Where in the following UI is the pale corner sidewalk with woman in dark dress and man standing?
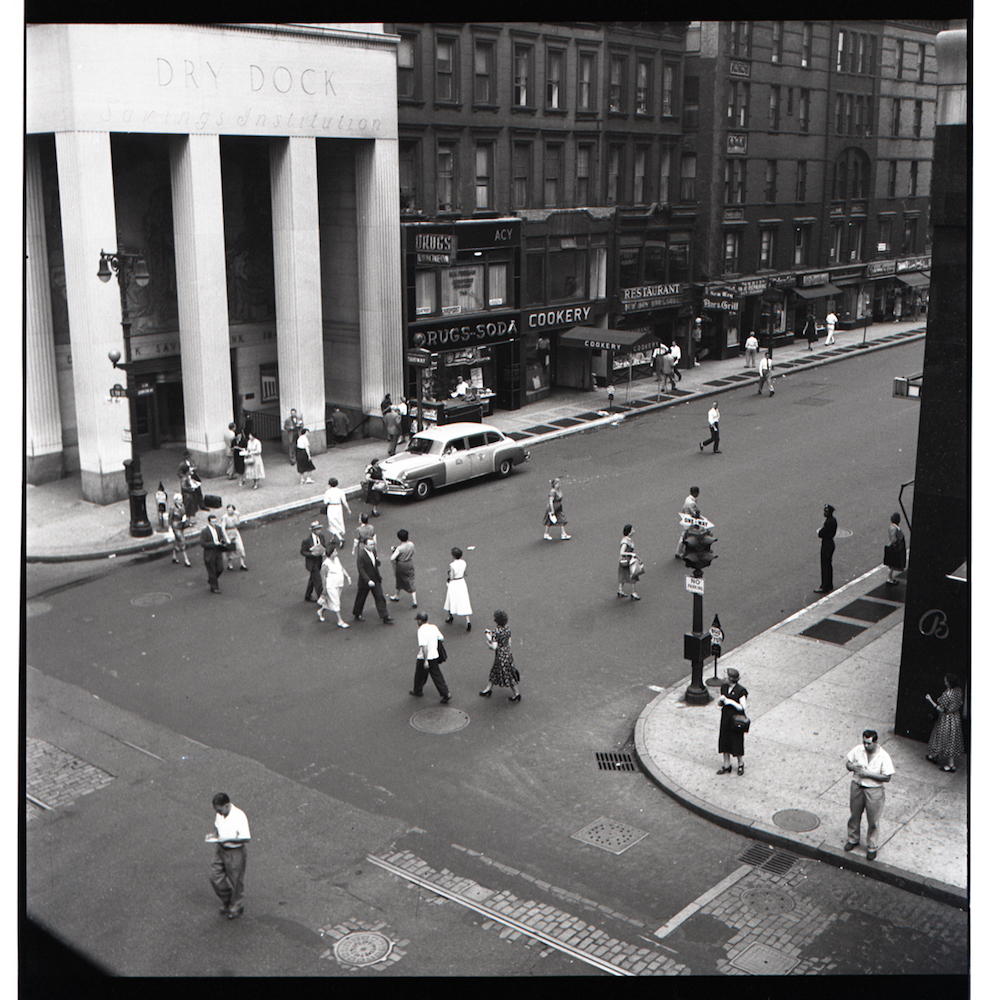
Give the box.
[635,567,969,909]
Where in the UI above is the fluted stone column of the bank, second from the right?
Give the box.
[271,136,326,454]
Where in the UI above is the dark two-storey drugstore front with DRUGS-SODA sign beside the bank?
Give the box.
[403,218,524,422]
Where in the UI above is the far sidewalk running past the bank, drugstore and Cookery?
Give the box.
[24,320,926,562]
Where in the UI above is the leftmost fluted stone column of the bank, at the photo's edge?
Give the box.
[24,136,64,485]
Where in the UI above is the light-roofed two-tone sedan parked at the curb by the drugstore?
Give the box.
[379,423,529,500]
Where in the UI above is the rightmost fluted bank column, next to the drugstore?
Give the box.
[355,139,405,415]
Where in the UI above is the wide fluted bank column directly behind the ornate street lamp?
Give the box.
[56,132,132,504]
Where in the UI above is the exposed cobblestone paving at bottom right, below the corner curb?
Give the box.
[369,842,968,976]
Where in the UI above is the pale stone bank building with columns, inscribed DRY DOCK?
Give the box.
[25,22,404,503]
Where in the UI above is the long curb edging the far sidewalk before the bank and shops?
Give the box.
[24,328,927,564]
